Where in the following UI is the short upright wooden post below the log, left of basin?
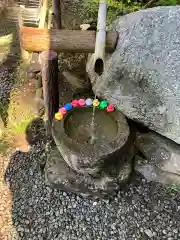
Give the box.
[39,51,59,135]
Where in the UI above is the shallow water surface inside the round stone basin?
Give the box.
[64,108,117,144]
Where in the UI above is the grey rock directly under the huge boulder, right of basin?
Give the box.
[136,132,180,175]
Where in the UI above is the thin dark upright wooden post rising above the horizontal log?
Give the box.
[53,0,62,29]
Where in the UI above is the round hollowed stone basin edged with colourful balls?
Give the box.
[52,107,130,175]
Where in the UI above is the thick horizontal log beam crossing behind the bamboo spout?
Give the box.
[20,27,117,53]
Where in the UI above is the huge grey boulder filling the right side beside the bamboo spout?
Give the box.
[87,6,180,143]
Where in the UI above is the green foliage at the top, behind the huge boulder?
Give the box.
[83,0,180,24]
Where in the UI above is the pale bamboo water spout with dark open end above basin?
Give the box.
[94,0,107,75]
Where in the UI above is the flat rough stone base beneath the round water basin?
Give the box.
[45,149,131,197]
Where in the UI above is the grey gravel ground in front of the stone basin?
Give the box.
[0,143,180,240]
